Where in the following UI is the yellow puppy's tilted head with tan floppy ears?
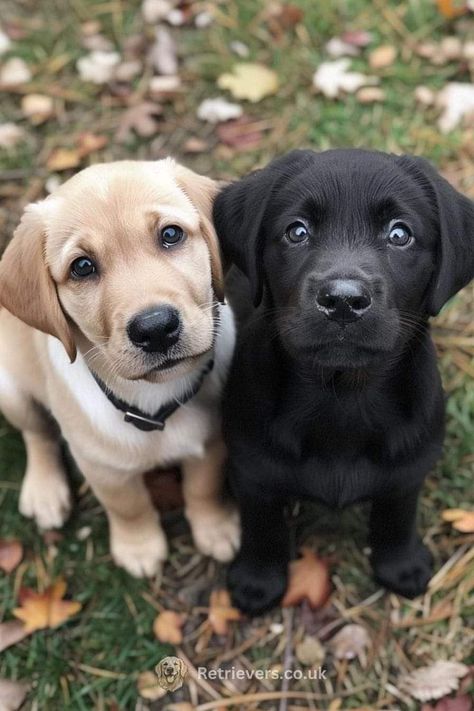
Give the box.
[0,159,222,382]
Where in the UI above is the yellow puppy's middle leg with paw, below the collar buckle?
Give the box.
[73,452,168,578]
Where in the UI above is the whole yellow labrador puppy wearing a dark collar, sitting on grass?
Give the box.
[0,159,239,576]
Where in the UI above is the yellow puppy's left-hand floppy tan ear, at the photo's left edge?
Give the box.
[0,205,76,362]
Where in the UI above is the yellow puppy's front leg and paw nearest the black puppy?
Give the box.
[182,440,240,562]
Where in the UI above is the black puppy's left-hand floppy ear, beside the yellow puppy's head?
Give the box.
[213,151,313,306]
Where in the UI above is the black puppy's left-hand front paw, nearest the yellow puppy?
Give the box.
[227,555,288,617]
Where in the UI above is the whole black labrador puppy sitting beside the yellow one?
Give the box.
[214,150,474,614]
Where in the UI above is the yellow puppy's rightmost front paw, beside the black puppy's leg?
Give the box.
[186,507,240,563]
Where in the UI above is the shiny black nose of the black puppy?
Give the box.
[316,279,372,323]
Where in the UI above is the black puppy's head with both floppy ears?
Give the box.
[214,145,474,368]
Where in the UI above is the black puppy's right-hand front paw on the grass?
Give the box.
[372,541,433,598]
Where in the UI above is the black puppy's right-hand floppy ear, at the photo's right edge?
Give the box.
[398,156,474,316]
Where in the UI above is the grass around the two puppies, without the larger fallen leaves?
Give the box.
[0,0,474,711]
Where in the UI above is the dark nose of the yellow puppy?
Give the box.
[127,305,181,353]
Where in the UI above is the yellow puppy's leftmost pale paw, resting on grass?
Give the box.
[19,471,71,530]
